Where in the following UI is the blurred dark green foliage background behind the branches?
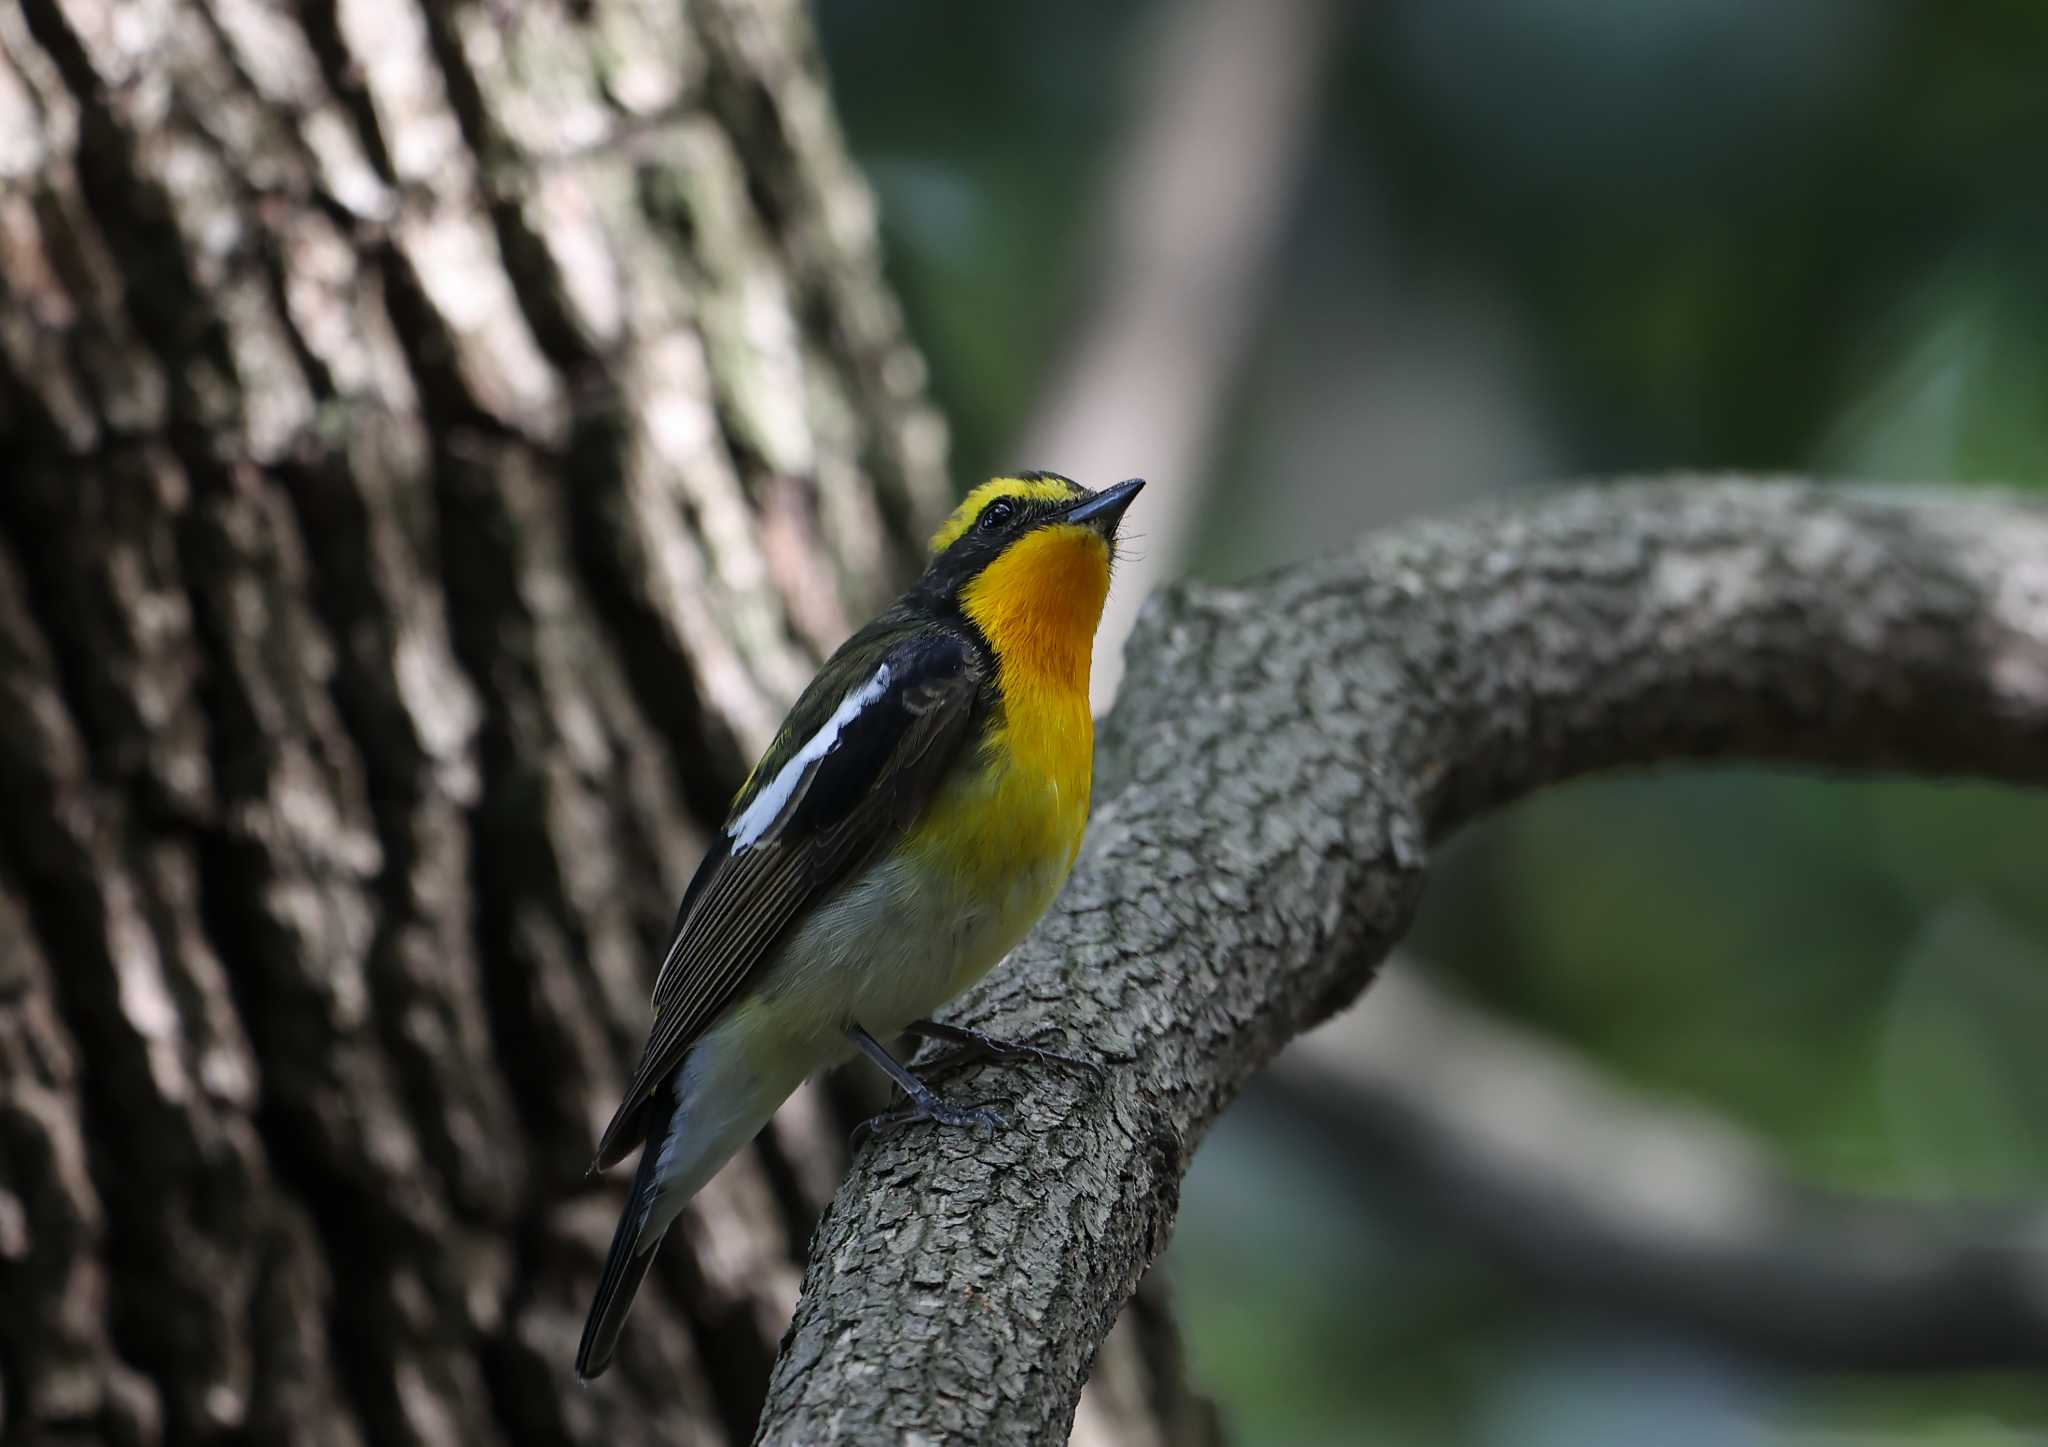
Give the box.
[815,0,2048,1447]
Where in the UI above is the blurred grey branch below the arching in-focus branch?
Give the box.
[1270,962,2048,1369]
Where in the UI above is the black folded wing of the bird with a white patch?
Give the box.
[598,630,985,1171]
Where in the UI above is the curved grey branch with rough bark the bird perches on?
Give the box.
[758,483,2048,1443]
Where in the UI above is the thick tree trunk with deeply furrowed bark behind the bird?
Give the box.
[0,0,1182,1447]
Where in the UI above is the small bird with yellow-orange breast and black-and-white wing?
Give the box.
[575,473,1145,1382]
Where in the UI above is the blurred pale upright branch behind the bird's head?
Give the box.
[1016,0,1337,712]
